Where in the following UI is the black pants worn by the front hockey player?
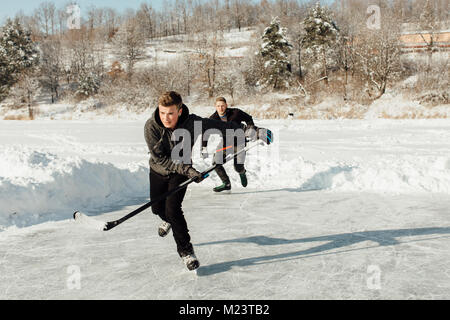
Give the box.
[150,169,193,256]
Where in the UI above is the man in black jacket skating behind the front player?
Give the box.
[201,97,255,192]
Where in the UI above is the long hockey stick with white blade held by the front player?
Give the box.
[73,141,263,231]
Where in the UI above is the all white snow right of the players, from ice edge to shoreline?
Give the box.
[194,120,450,194]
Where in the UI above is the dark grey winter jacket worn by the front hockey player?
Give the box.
[144,104,245,176]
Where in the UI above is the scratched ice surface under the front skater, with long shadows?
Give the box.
[0,188,450,299]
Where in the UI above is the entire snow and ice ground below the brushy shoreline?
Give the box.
[0,118,450,299]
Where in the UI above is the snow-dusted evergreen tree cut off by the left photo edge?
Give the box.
[0,19,39,100]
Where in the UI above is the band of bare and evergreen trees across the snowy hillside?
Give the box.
[0,0,449,117]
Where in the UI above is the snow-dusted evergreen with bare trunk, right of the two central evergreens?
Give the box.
[302,2,339,83]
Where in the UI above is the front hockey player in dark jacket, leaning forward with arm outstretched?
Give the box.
[144,91,270,270]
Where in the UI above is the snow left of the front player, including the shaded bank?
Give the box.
[0,121,148,227]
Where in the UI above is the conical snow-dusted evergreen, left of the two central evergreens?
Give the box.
[258,17,292,89]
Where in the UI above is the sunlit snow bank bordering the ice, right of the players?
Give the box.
[197,147,450,194]
